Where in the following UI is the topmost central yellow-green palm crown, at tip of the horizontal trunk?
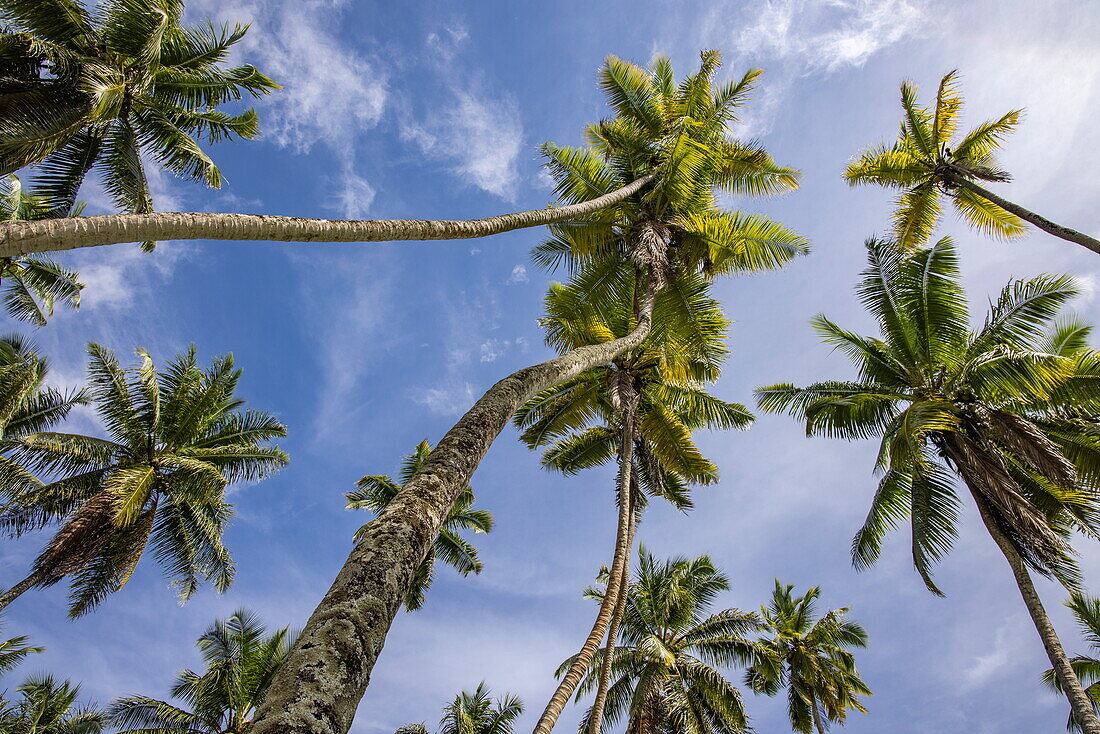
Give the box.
[534,51,809,290]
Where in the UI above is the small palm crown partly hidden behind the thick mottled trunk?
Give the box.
[344,441,493,612]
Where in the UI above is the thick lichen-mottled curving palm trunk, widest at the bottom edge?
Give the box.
[250,272,658,734]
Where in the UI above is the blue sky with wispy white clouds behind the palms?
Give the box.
[0,0,1100,734]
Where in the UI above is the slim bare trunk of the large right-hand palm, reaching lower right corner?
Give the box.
[970,489,1100,734]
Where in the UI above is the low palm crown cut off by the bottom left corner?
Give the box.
[0,676,107,734]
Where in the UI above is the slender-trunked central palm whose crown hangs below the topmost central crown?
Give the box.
[514,270,752,734]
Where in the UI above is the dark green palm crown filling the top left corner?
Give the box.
[0,0,277,232]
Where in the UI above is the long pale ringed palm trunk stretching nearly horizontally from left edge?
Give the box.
[0,174,653,258]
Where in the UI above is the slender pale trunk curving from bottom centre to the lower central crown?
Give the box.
[535,407,636,734]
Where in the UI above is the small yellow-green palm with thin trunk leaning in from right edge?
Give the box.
[845,72,1100,253]
